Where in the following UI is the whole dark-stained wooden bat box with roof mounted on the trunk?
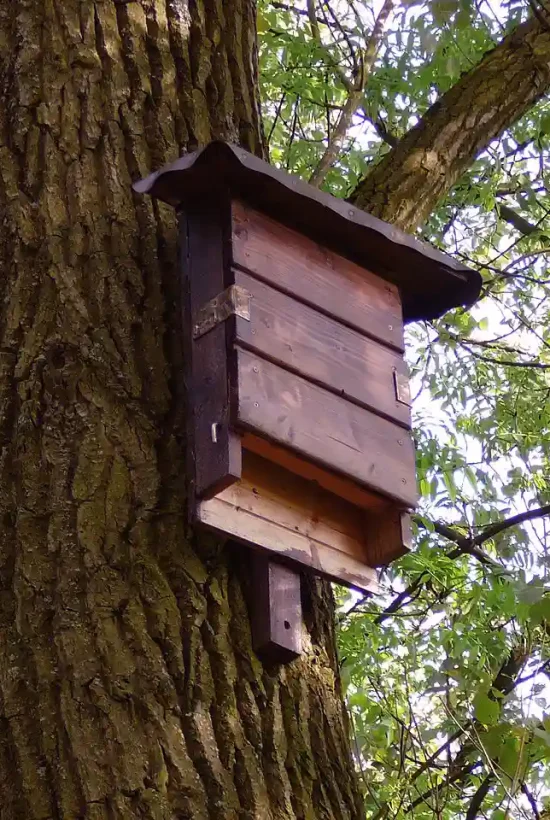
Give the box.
[134,143,481,660]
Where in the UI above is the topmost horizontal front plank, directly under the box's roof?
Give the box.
[232,201,403,350]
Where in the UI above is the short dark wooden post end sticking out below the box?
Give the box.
[250,552,302,663]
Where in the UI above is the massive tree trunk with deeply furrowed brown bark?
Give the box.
[0,0,361,820]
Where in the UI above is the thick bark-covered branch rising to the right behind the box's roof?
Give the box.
[351,18,550,232]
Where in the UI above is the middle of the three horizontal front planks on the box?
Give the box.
[234,270,410,428]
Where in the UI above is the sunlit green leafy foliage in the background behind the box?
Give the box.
[259,0,550,820]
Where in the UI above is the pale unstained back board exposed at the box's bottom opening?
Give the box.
[196,453,377,592]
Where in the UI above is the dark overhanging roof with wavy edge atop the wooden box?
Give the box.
[134,142,481,321]
